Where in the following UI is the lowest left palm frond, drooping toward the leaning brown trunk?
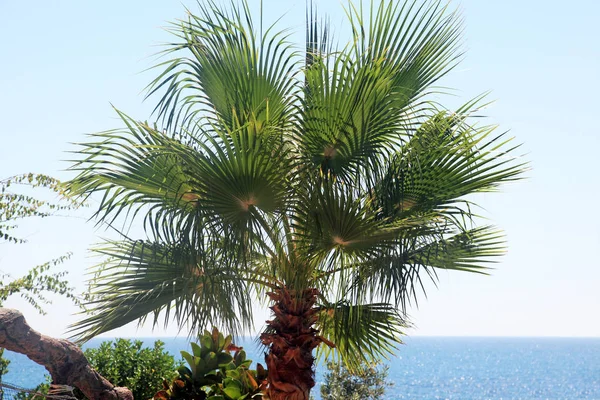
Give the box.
[72,236,258,341]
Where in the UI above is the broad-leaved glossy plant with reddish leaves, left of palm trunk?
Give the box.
[154,328,267,400]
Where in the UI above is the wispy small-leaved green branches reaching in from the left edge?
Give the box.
[0,173,79,380]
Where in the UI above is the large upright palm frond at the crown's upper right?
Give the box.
[297,1,461,179]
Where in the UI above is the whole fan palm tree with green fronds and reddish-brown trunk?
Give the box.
[69,1,524,400]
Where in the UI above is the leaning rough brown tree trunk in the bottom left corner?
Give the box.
[0,308,133,400]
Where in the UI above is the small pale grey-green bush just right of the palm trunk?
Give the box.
[321,362,393,400]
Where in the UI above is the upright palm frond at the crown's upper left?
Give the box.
[148,0,299,134]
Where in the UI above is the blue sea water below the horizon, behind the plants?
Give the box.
[4,337,600,400]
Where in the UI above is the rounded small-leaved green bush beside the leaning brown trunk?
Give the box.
[76,339,180,399]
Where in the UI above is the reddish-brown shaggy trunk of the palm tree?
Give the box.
[260,288,332,400]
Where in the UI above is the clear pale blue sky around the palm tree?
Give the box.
[0,0,600,336]
